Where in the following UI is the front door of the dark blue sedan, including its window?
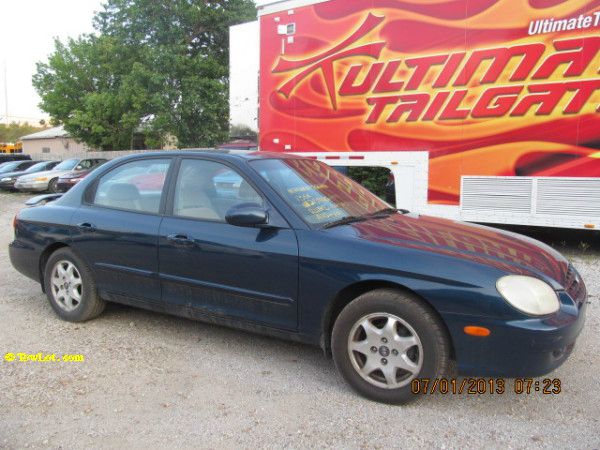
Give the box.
[159,158,298,330]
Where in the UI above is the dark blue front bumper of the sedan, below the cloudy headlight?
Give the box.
[445,292,587,378]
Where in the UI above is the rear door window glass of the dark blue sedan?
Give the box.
[93,159,171,214]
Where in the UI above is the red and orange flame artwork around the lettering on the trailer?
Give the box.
[260,0,600,205]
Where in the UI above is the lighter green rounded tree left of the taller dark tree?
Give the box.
[33,35,151,150]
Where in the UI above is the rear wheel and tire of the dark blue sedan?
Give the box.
[44,247,105,322]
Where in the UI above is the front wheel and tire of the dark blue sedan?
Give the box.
[331,289,451,404]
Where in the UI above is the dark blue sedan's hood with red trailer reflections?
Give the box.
[327,214,569,285]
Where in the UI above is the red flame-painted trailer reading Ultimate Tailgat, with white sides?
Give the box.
[230,0,600,229]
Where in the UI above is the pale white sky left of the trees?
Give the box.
[0,0,103,123]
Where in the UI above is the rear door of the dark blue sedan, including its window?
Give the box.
[71,157,172,303]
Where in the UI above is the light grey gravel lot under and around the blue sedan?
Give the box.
[0,194,600,449]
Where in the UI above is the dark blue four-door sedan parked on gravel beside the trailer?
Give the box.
[10,152,587,403]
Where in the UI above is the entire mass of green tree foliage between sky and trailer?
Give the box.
[33,0,256,150]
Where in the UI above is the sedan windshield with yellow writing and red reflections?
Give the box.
[250,159,390,225]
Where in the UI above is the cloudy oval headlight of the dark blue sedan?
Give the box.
[496,275,560,316]
